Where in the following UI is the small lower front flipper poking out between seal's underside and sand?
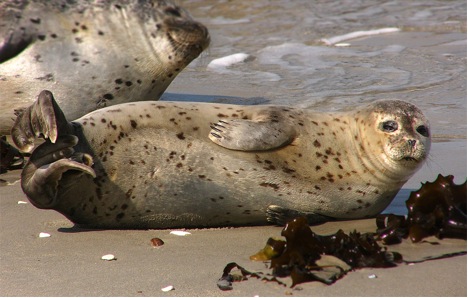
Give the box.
[266,205,334,226]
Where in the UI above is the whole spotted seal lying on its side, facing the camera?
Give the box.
[12,91,431,228]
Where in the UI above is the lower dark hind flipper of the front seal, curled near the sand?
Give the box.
[21,135,96,209]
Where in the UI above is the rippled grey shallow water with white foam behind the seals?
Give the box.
[164,0,467,138]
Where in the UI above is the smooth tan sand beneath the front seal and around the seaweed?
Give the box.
[0,140,467,296]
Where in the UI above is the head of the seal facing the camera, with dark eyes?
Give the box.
[356,100,431,179]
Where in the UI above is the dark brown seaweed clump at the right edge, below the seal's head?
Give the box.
[377,174,467,244]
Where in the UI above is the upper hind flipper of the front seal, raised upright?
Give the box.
[11,90,71,152]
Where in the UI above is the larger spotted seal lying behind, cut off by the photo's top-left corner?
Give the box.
[0,0,210,134]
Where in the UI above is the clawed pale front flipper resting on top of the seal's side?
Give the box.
[209,119,294,151]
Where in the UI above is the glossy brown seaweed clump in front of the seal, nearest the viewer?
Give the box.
[218,217,402,290]
